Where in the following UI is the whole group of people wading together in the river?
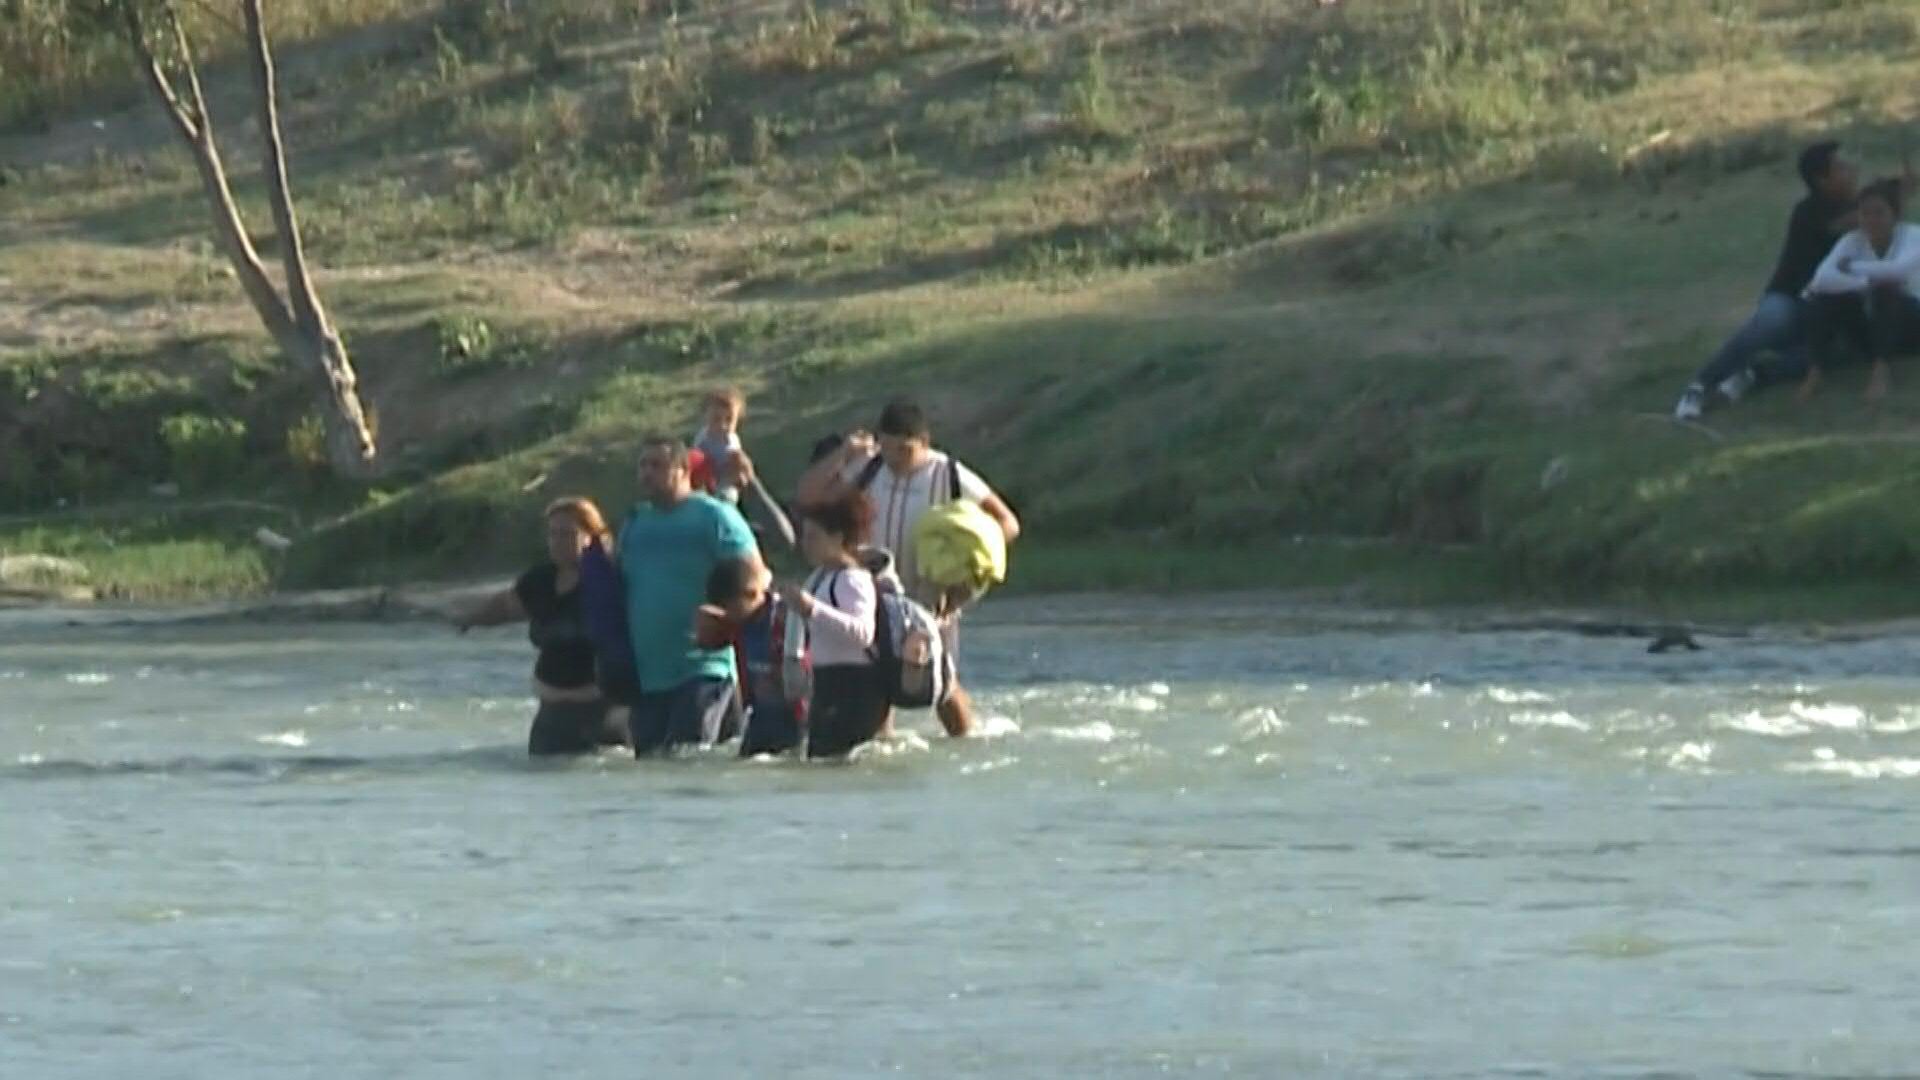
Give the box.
[455,390,1020,757]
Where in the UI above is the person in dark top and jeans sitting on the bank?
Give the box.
[1674,142,1859,421]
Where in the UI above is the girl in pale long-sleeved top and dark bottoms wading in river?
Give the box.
[785,492,889,757]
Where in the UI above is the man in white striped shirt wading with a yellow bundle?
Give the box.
[799,402,1020,736]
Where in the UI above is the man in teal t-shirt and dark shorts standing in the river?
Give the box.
[620,436,760,755]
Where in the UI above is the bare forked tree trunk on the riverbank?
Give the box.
[123,0,376,477]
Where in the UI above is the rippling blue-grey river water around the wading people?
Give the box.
[0,601,1920,1080]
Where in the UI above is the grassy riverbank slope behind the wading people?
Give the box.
[0,0,1920,617]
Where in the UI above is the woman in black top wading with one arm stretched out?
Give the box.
[453,500,626,755]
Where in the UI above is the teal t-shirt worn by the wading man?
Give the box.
[620,494,756,694]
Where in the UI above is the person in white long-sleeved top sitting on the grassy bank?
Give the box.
[1801,181,1920,402]
